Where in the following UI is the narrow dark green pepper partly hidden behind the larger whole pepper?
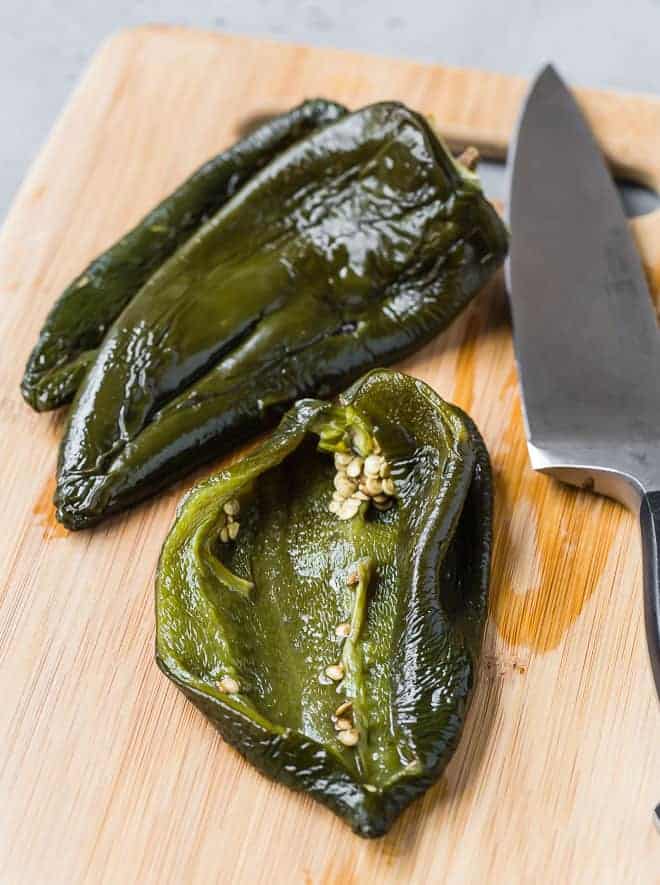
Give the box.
[21,99,346,412]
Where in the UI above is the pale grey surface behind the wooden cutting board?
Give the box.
[0,0,660,219]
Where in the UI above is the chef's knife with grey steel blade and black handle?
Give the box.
[507,66,660,696]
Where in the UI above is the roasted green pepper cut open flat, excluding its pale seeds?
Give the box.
[156,370,492,837]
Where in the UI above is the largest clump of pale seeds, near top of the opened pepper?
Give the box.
[328,443,396,519]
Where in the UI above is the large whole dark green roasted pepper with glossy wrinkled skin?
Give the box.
[55,102,507,529]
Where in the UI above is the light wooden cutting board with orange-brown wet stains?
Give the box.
[0,27,660,885]
